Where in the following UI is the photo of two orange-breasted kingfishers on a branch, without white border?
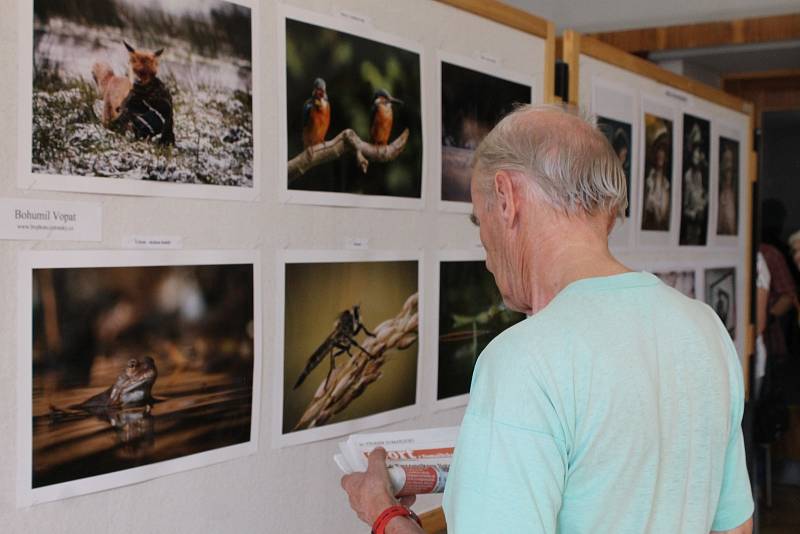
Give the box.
[286,18,423,198]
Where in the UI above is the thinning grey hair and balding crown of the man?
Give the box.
[472,105,630,217]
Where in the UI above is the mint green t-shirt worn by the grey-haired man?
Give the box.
[444,273,753,534]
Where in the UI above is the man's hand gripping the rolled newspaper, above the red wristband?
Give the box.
[342,447,415,526]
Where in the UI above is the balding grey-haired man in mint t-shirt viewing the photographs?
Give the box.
[342,106,753,534]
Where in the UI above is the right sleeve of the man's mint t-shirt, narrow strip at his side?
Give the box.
[711,339,753,530]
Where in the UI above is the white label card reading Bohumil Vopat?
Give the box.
[0,198,103,241]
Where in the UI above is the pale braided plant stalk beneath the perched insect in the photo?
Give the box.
[292,293,419,430]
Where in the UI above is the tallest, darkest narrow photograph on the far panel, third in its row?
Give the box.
[679,113,711,246]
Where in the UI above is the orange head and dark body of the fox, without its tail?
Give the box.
[117,41,175,145]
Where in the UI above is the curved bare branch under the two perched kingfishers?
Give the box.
[287,128,409,183]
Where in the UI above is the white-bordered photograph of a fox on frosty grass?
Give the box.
[18,0,261,200]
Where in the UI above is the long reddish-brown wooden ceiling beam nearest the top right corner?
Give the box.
[587,13,800,54]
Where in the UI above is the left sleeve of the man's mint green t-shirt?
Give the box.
[444,342,567,534]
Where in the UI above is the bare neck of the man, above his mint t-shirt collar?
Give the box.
[525,216,630,314]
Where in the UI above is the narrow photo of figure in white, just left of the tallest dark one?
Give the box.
[642,113,672,232]
